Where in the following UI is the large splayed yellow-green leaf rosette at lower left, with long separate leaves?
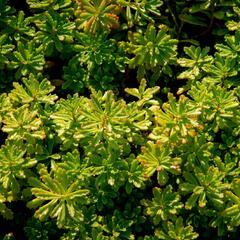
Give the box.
[27,166,89,228]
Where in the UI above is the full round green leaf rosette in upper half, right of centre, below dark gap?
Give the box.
[125,24,177,79]
